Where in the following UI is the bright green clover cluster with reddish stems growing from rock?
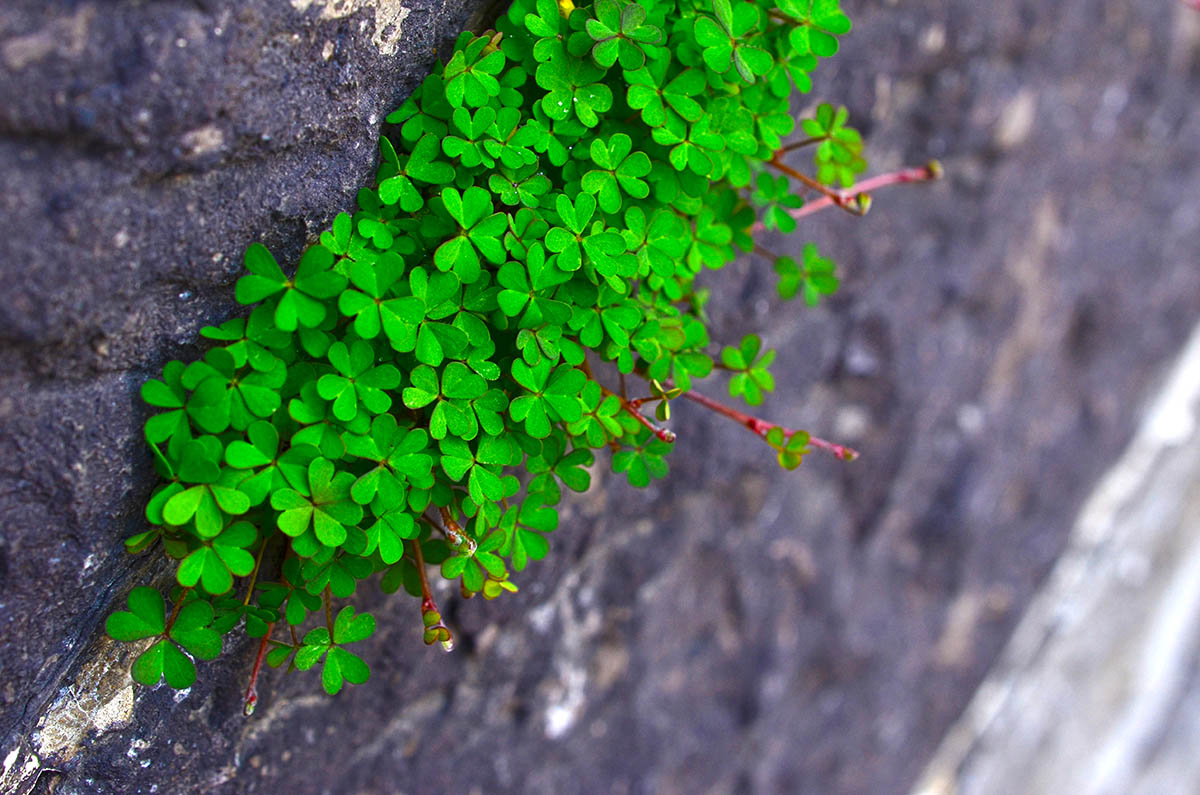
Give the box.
[108,0,936,710]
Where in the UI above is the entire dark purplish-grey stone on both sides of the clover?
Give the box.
[0,0,1200,794]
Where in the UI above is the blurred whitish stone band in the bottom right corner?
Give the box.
[914,328,1200,795]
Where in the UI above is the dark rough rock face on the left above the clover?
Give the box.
[0,0,481,789]
